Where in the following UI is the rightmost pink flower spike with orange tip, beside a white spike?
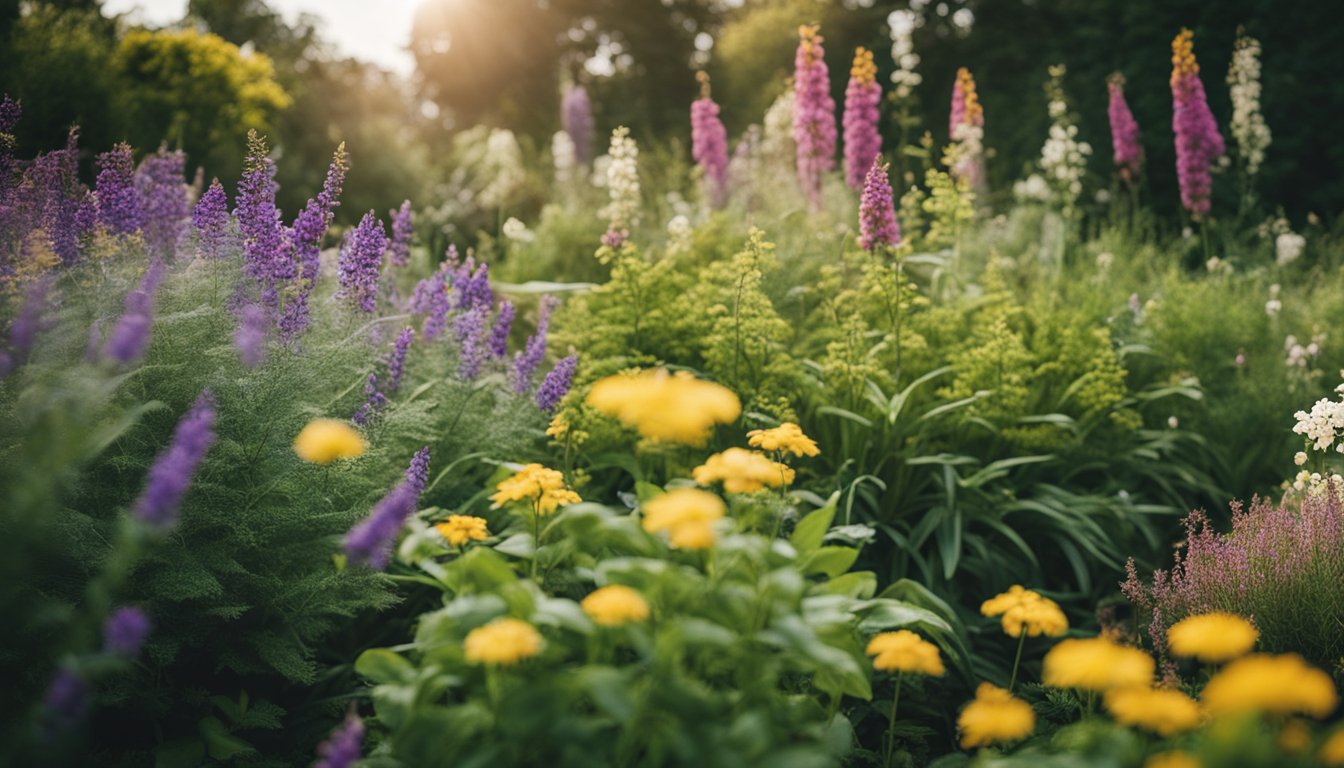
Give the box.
[1171,30,1226,219]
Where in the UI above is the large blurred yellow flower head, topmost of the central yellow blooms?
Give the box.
[587,369,742,445]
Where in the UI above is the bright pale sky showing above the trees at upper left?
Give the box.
[102,0,419,75]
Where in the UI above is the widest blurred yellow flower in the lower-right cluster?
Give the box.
[1203,654,1339,718]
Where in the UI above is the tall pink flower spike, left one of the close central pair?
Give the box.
[793,26,836,208]
